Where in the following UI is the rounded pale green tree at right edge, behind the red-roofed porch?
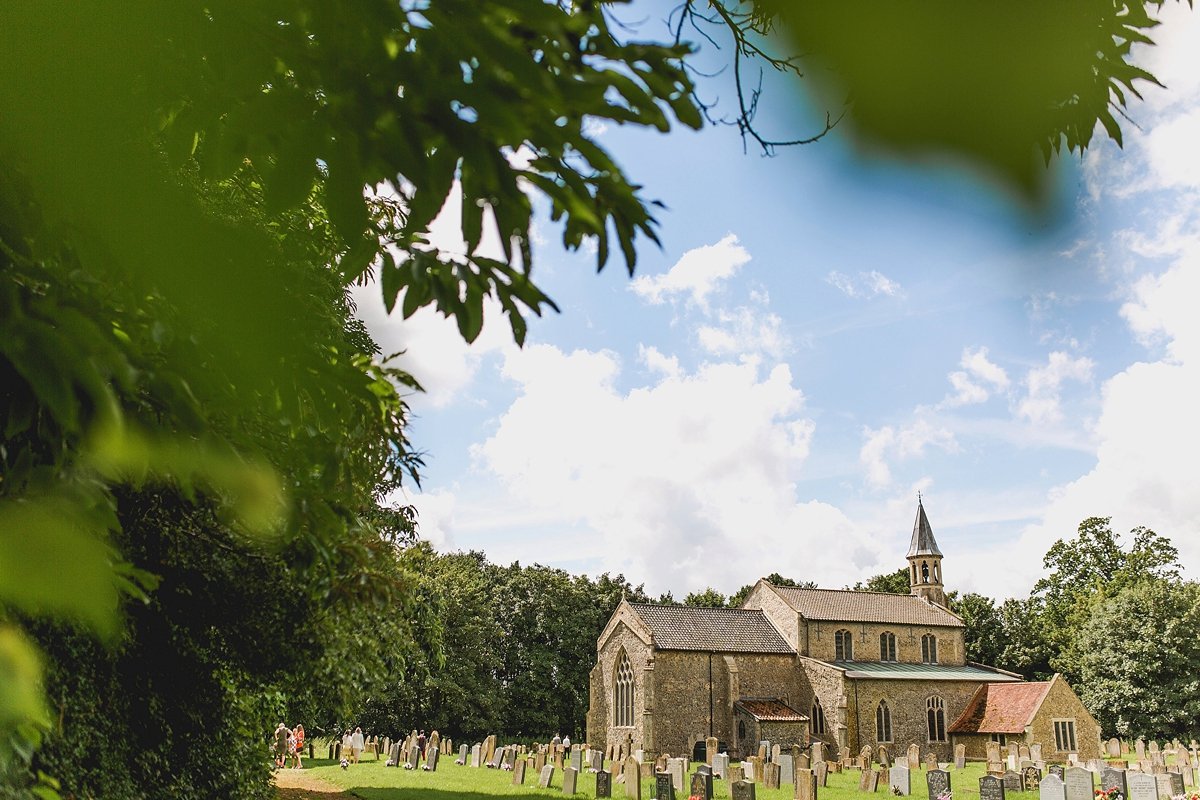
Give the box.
[1056,578,1200,739]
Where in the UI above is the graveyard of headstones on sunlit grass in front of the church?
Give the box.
[274,740,1196,800]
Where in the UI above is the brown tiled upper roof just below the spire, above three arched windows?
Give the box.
[772,585,962,627]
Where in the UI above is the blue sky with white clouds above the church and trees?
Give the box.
[359,4,1200,597]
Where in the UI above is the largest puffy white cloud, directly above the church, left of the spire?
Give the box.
[475,344,878,594]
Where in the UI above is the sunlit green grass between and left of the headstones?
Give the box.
[288,758,1038,800]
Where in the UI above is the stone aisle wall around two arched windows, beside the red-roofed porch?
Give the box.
[846,679,979,762]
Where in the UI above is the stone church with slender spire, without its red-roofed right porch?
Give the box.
[587,503,1027,762]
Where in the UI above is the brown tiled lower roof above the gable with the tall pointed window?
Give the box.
[630,603,796,654]
